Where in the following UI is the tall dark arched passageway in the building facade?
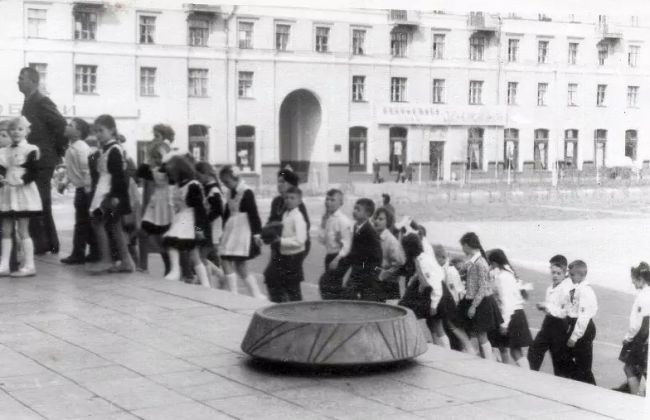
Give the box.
[280,89,326,182]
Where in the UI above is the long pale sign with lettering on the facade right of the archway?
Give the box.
[375,103,506,126]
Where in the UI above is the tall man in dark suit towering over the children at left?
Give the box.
[18,67,68,255]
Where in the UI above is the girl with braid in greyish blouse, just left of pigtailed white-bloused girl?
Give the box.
[457,232,503,360]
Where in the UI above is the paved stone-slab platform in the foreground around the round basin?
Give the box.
[0,259,644,420]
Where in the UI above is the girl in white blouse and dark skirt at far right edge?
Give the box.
[616,262,650,395]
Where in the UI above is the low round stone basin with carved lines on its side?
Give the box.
[241,300,427,366]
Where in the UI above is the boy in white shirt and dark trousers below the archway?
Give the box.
[265,187,308,303]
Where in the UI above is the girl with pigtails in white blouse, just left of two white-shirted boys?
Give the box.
[487,249,533,369]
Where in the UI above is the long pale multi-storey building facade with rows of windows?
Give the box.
[0,0,650,183]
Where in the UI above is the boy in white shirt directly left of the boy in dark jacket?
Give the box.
[318,189,352,300]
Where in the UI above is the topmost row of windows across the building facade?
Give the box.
[27,8,641,67]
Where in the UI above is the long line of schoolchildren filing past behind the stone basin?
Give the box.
[0,115,650,393]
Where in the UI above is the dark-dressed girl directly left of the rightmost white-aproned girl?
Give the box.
[196,162,225,289]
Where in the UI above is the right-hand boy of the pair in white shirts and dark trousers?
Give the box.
[567,260,598,385]
